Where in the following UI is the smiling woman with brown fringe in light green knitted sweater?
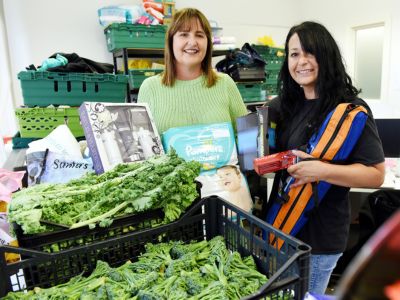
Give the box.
[138,8,247,133]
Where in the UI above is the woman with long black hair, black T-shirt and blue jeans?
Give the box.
[266,22,385,294]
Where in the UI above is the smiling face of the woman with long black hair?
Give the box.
[288,33,318,99]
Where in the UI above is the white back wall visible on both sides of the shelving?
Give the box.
[4,0,292,110]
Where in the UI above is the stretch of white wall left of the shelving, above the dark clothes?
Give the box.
[4,0,136,105]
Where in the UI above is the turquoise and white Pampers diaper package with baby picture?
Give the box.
[162,122,252,212]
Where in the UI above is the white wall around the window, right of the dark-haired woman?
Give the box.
[301,0,400,118]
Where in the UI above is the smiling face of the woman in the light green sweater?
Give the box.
[173,19,207,77]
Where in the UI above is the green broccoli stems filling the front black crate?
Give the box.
[4,236,272,300]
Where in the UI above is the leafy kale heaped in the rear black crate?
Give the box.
[8,150,200,234]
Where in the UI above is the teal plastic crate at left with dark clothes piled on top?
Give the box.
[18,71,128,106]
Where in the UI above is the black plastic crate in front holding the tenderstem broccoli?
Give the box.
[0,196,310,299]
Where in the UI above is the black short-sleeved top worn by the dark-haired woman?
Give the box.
[267,98,385,254]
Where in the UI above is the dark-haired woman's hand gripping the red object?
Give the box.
[287,150,324,187]
